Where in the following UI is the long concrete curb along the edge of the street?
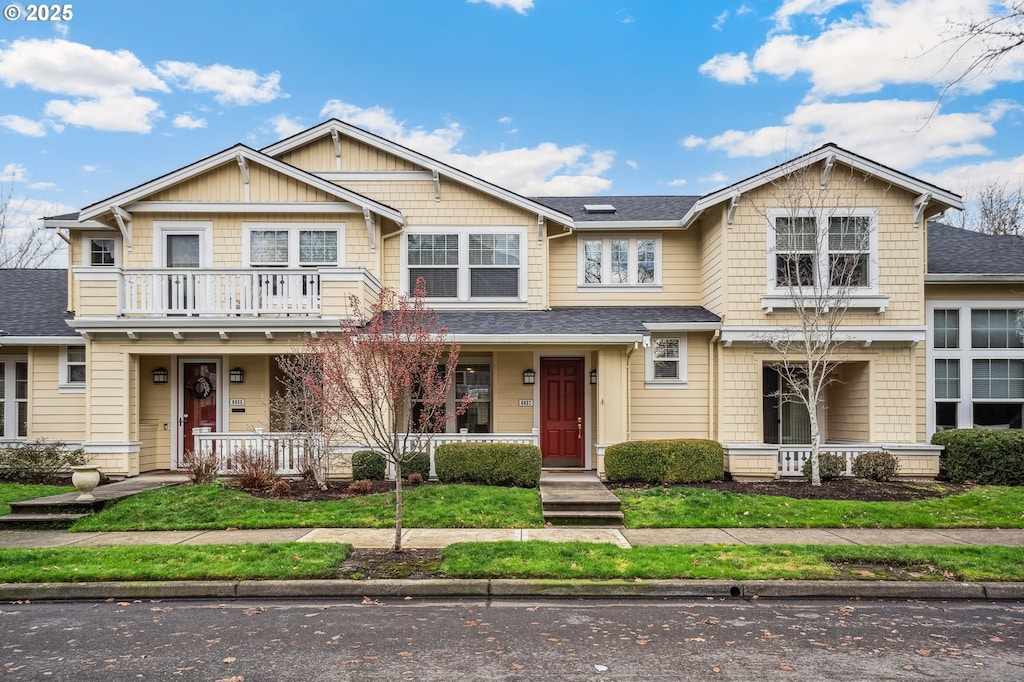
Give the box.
[0,579,1024,602]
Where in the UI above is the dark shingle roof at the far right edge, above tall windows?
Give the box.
[928,222,1024,274]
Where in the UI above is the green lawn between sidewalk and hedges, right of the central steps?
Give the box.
[615,485,1024,528]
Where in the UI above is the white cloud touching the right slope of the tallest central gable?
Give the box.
[321,99,614,196]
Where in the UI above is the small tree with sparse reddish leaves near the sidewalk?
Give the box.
[281,279,472,551]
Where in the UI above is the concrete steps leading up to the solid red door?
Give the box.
[541,471,623,526]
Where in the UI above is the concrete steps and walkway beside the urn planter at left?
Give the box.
[0,472,186,530]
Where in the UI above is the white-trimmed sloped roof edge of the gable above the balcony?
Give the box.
[78,142,406,225]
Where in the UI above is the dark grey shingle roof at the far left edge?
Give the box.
[0,269,79,338]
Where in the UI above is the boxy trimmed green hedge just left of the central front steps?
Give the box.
[434,442,541,487]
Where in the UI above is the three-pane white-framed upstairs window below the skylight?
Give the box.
[578,236,662,287]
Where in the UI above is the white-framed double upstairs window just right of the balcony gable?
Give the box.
[402,228,525,301]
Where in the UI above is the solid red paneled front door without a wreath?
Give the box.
[541,357,584,467]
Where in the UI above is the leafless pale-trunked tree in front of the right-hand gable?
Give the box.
[762,159,876,485]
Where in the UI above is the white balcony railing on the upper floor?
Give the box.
[119,268,321,316]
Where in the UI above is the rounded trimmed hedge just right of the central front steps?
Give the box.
[604,438,725,484]
